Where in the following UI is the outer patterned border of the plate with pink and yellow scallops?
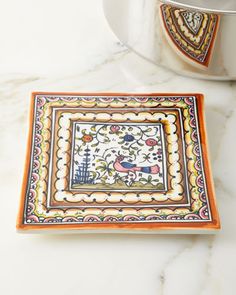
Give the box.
[18,94,219,232]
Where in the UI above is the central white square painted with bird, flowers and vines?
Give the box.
[70,122,167,191]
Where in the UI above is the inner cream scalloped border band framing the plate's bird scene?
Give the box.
[48,108,188,207]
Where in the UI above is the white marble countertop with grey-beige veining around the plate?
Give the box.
[0,0,236,295]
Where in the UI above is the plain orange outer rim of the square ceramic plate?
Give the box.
[16,92,220,234]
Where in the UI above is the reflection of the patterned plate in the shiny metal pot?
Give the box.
[160,4,219,67]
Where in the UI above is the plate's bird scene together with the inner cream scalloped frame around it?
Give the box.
[47,107,189,208]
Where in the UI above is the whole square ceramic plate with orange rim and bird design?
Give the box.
[17,93,219,233]
